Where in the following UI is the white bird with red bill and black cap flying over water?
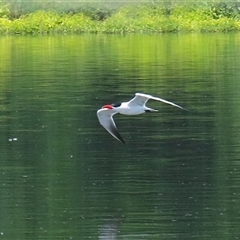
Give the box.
[97,93,186,144]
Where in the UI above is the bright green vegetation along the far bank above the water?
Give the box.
[0,2,240,34]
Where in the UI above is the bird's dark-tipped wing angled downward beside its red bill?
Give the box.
[97,109,125,144]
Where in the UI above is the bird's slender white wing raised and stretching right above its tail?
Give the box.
[129,93,187,110]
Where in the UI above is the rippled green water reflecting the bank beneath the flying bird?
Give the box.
[0,33,240,240]
